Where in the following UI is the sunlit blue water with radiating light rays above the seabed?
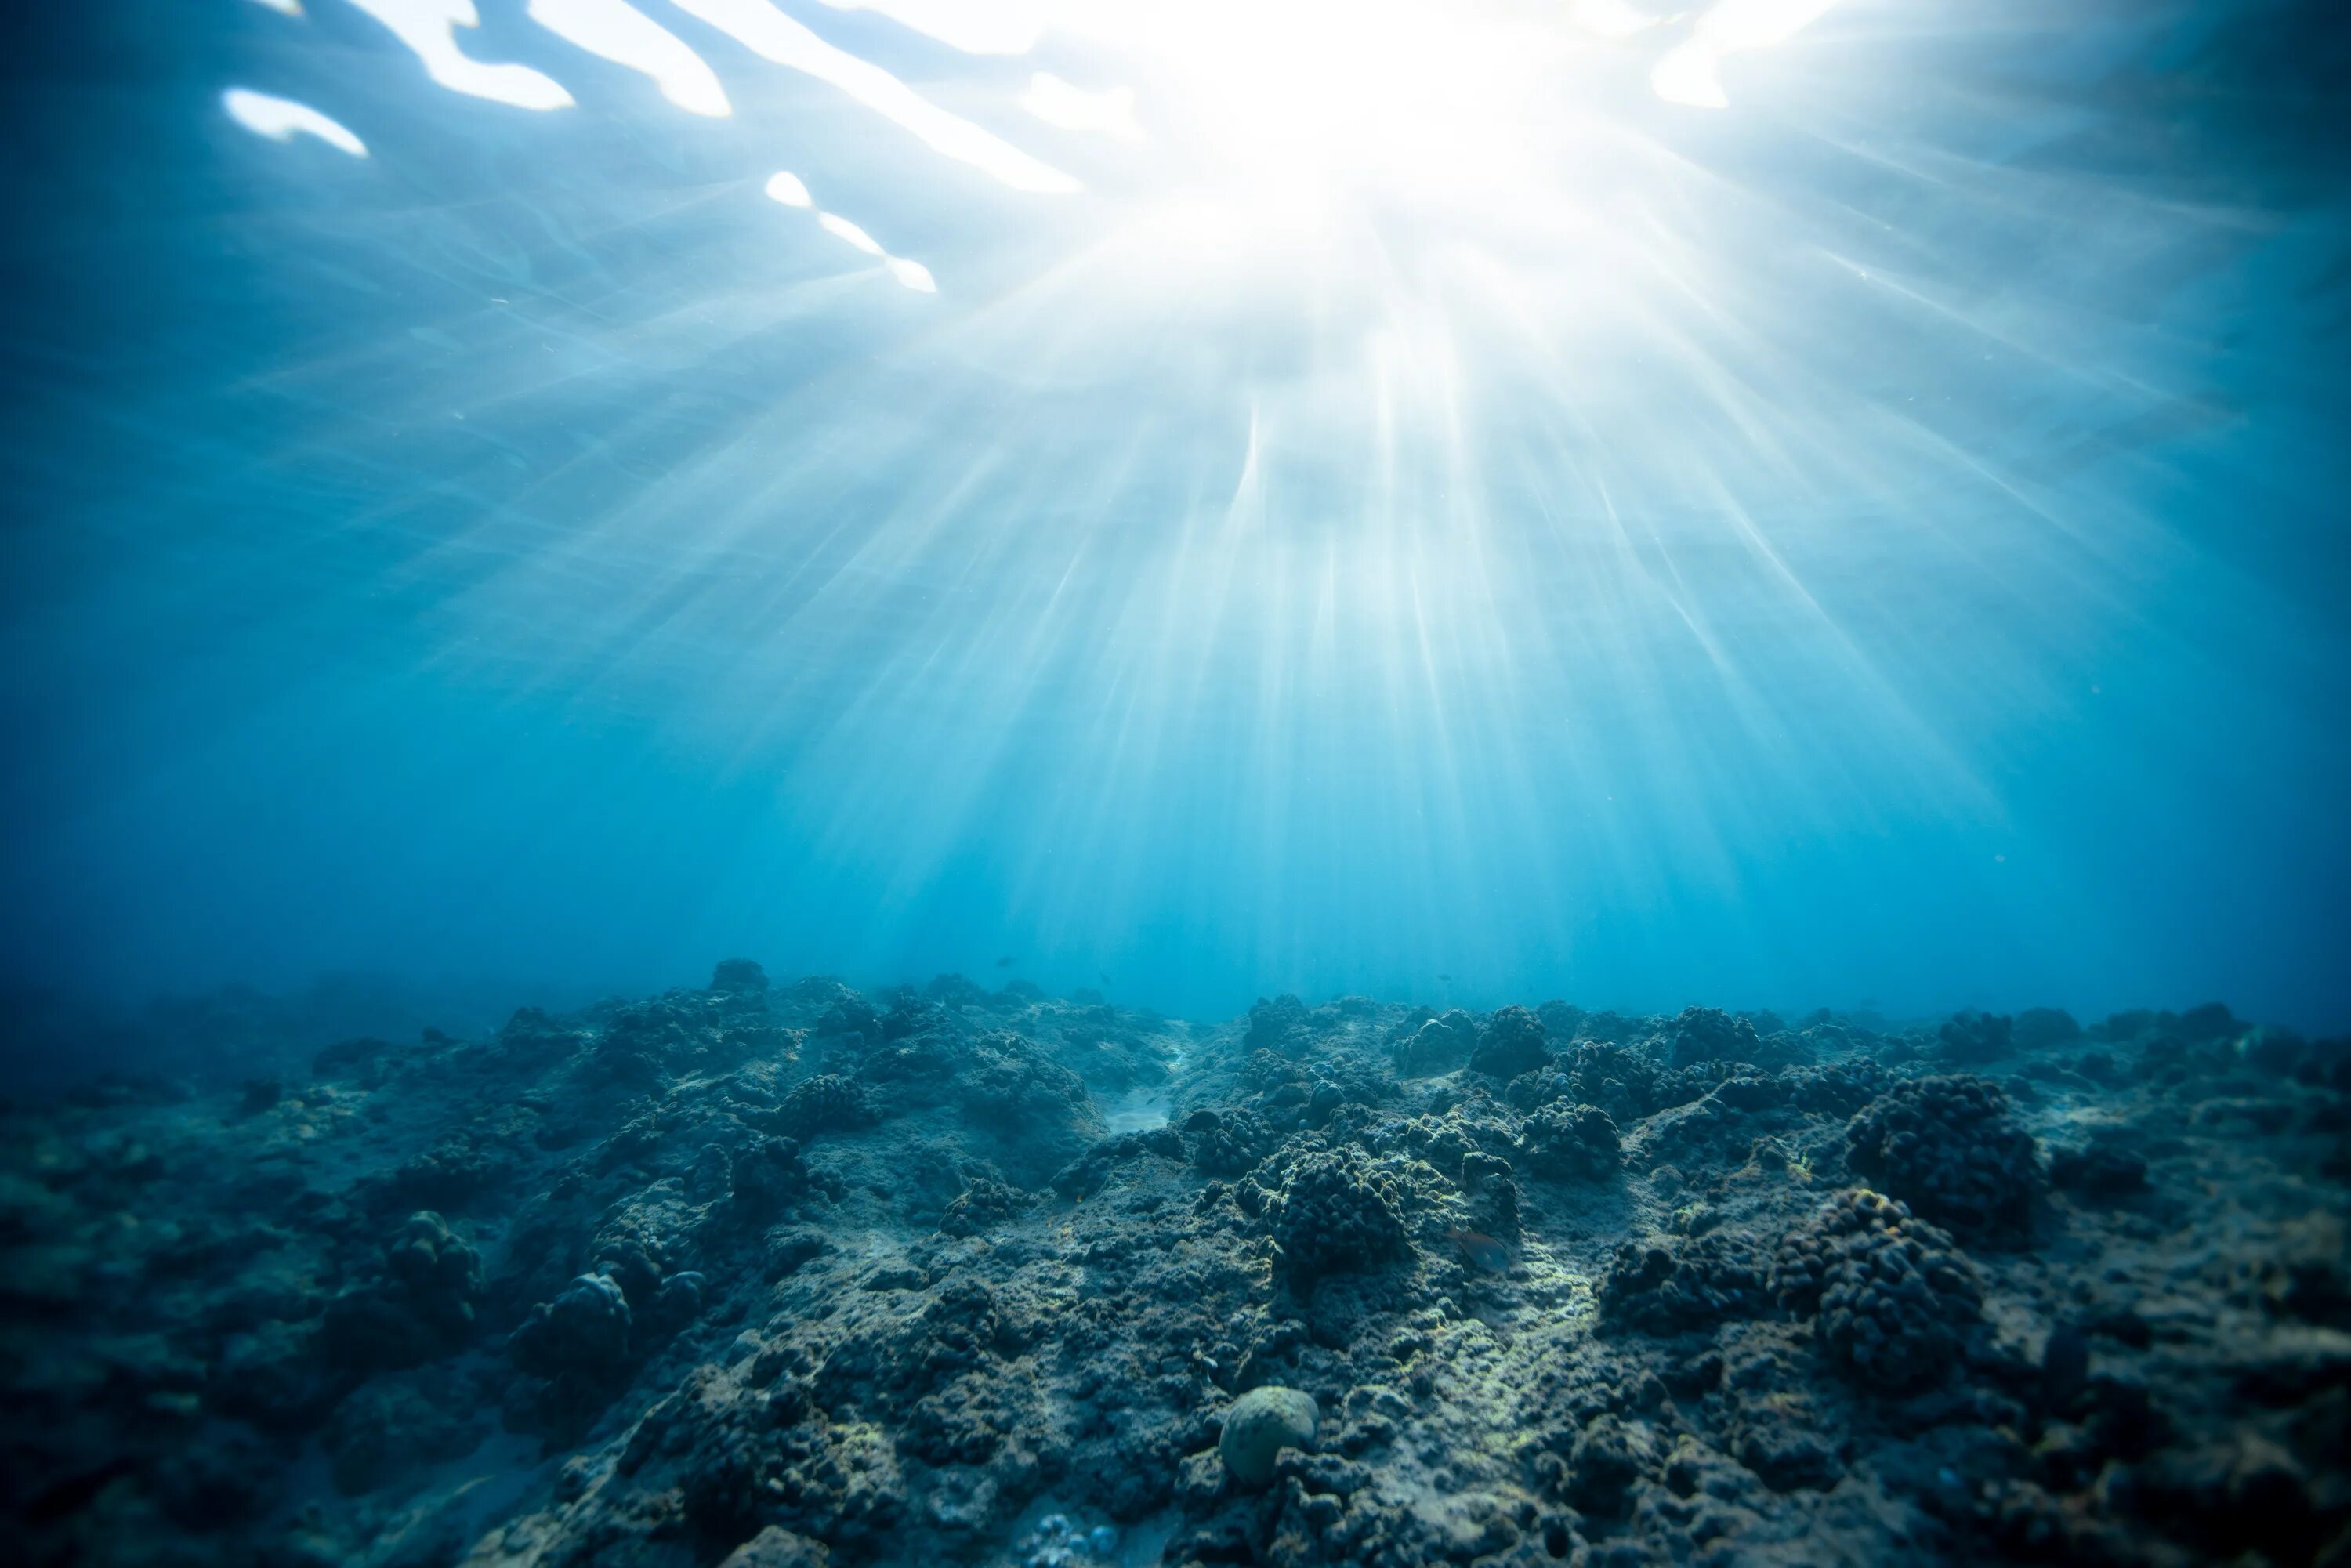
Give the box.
[0,0,2351,1027]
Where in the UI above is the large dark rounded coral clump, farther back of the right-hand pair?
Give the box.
[1846,1074,2041,1237]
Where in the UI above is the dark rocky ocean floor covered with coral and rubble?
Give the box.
[0,961,2351,1568]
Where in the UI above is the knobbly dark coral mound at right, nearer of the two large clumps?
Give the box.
[1773,1190,1982,1394]
